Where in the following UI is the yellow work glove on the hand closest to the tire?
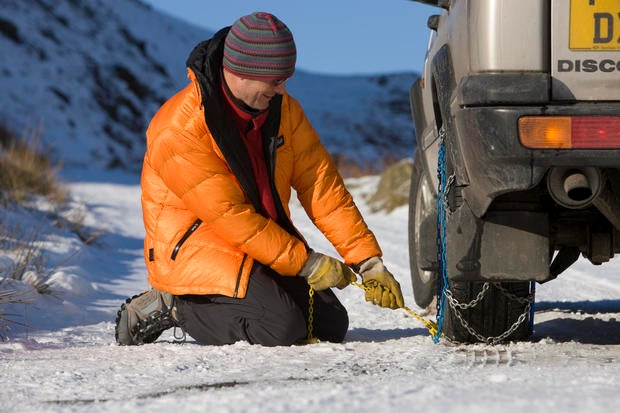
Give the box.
[359,257,405,309]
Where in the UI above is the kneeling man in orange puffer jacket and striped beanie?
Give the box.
[116,12,403,346]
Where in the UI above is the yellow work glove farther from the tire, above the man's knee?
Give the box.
[299,251,356,291]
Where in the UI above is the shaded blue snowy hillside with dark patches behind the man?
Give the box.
[0,0,415,171]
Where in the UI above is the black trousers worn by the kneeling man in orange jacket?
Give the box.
[177,263,349,346]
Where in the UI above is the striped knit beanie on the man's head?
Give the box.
[223,12,297,80]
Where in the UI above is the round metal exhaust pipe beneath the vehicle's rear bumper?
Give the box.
[547,166,620,230]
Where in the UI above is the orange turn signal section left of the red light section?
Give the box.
[519,116,572,149]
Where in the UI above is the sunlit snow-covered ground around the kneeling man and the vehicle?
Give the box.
[0,172,620,413]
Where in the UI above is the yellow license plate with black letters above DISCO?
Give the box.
[569,0,620,51]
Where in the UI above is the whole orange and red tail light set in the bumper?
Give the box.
[519,116,620,149]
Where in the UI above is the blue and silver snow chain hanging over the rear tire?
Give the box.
[432,127,534,344]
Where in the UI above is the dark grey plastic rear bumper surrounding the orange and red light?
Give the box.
[454,102,620,217]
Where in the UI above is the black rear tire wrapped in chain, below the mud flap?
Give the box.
[443,281,534,344]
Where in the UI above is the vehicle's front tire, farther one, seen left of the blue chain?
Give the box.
[408,147,437,308]
